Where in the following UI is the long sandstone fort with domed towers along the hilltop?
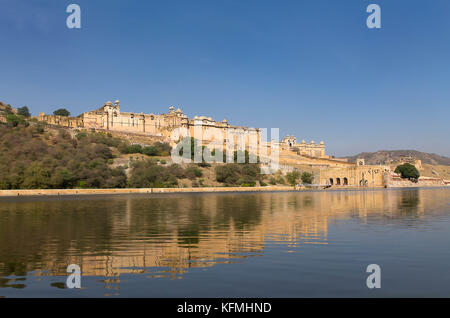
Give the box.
[27,100,445,187]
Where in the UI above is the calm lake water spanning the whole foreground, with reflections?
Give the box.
[0,188,450,297]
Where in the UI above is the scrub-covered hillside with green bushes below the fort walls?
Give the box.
[0,118,268,190]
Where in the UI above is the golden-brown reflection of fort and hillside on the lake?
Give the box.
[0,189,449,289]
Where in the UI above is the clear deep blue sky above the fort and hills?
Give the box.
[0,0,450,156]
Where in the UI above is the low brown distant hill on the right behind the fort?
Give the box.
[345,150,450,166]
